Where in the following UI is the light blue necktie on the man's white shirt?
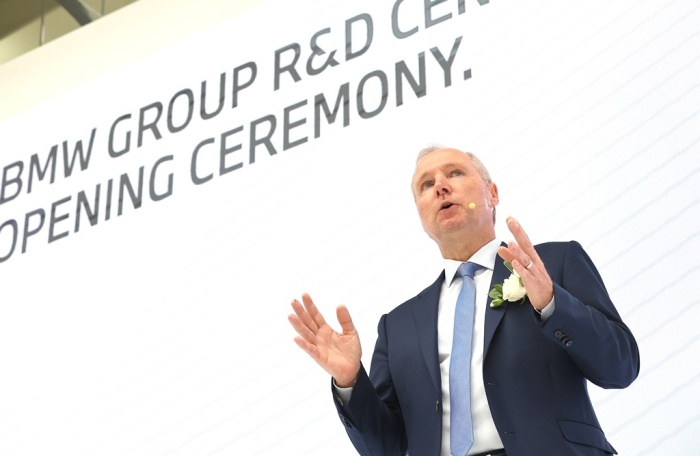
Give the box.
[450,262,482,456]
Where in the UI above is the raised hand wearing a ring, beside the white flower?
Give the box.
[498,217,554,310]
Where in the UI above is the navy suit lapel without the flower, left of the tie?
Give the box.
[413,271,445,391]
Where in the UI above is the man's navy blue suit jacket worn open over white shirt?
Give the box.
[335,241,639,456]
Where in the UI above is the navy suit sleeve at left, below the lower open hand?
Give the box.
[331,315,408,456]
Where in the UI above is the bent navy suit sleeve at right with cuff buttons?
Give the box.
[542,241,639,388]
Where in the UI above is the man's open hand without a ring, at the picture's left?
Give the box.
[289,293,362,388]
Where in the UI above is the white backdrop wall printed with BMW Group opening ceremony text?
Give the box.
[0,0,700,455]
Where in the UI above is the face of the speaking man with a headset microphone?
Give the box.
[412,149,498,244]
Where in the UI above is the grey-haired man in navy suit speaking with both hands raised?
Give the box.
[289,148,639,456]
